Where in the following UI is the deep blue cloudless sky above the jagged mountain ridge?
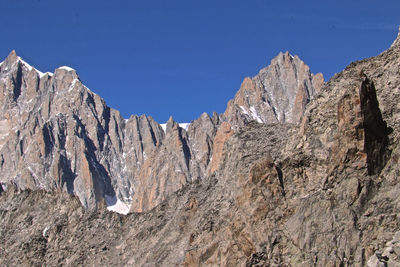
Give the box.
[0,0,400,123]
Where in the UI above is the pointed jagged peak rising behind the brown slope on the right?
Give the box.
[224,52,324,125]
